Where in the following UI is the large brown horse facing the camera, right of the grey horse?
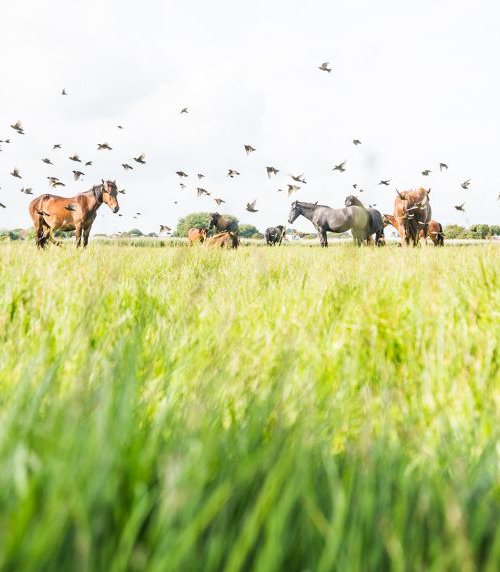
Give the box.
[394,188,432,246]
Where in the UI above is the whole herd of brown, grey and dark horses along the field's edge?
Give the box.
[29,180,444,248]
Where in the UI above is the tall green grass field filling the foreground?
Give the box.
[0,242,500,572]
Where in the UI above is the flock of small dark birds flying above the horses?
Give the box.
[0,67,484,223]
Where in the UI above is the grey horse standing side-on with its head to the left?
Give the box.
[288,201,369,247]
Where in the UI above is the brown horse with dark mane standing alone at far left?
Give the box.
[29,180,120,248]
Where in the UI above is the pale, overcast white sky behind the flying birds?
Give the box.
[0,0,500,233]
